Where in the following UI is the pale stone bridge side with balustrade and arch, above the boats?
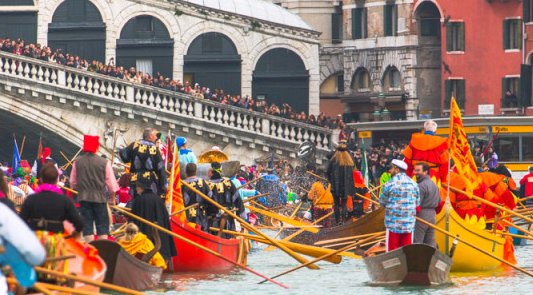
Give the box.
[0,52,331,164]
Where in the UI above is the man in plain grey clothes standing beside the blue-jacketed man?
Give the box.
[414,163,440,248]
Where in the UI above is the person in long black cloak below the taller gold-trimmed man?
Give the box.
[131,172,176,259]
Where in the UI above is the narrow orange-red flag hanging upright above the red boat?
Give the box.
[166,145,187,223]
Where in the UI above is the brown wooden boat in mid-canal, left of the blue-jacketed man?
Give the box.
[284,208,385,249]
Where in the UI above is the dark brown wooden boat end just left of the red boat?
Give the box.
[91,240,163,291]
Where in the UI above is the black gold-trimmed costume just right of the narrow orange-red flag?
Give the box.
[181,176,218,231]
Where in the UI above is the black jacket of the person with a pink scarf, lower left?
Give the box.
[20,191,83,233]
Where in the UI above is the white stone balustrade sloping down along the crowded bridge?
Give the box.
[0,52,332,150]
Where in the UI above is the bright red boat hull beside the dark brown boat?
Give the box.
[171,217,239,272]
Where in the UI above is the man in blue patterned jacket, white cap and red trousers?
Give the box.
[379,159,420,252]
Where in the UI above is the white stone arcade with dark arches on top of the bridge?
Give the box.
[0,0,320,113]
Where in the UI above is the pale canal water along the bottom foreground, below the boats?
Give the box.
[156,241,533,295]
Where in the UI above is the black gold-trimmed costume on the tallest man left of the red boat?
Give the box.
[119,140,167,195]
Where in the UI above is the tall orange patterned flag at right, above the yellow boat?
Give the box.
[448,97,481,194]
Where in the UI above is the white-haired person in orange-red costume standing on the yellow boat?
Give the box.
[403,120,449,183]
